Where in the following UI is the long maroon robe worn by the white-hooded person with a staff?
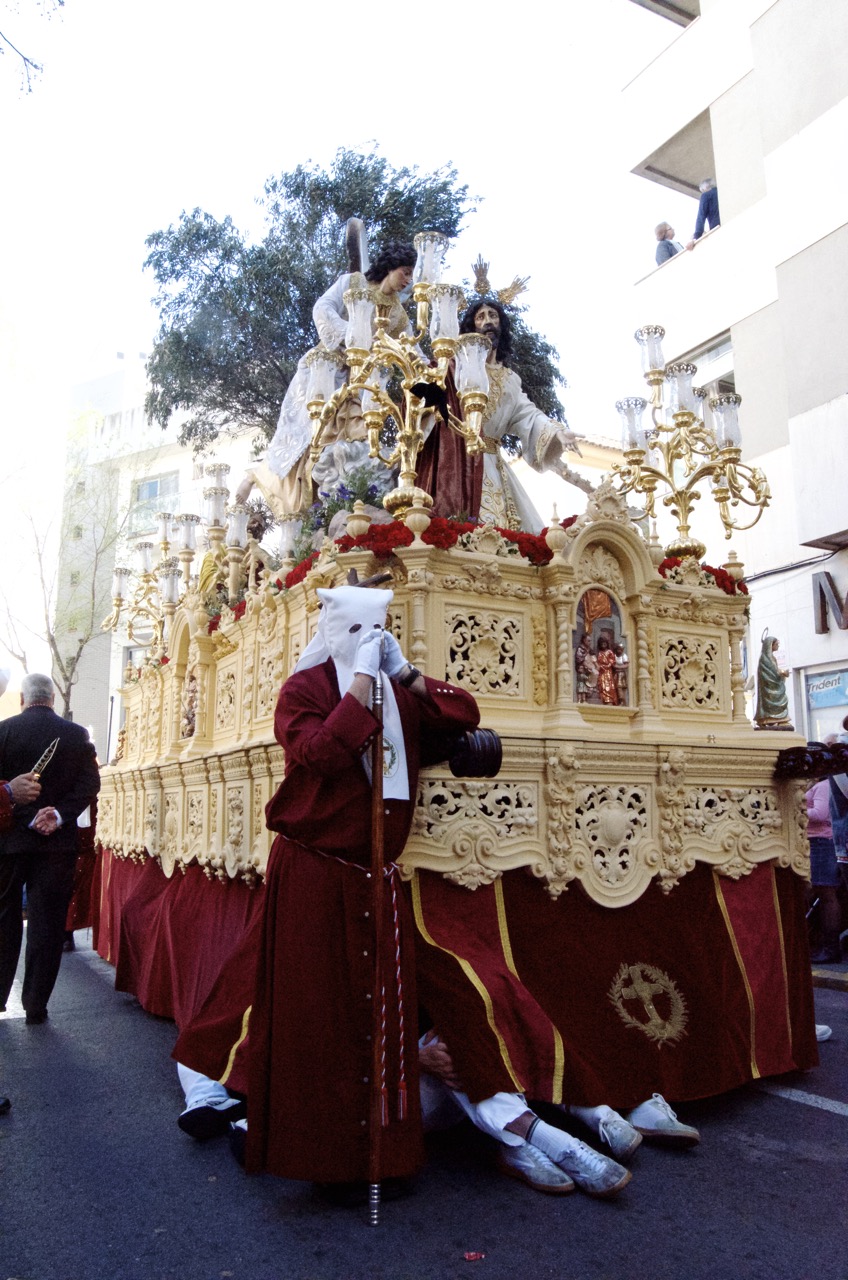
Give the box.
[246,660,479,1181]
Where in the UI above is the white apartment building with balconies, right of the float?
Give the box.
[621,0,848,739]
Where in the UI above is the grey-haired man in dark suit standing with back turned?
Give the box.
[0,675,100,1024]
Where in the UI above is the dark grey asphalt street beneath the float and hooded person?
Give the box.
[0,932,848,1280]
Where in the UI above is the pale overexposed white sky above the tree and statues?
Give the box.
[0,0,696,675]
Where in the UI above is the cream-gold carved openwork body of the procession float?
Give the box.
[99,501,807,901]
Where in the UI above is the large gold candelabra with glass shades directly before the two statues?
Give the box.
[306,232,491,529]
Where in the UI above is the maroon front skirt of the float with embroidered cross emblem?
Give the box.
[414,865,817,1108]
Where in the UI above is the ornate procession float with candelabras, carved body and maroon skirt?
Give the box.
[94,236,817,1106]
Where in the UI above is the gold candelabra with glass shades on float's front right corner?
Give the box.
[612,325,771,559]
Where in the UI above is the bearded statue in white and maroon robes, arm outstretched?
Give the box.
[418,298,592,534]
